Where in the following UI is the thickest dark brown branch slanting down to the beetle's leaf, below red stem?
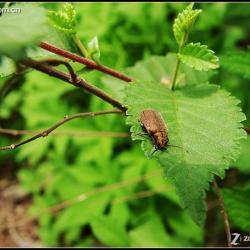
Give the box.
[21,59,127,113]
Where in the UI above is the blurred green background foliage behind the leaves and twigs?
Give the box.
[0,3,250,247]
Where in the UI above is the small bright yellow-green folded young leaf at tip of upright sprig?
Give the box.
[173,3,202,47]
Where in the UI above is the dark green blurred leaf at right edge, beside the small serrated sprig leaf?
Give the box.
[220,50,250,79]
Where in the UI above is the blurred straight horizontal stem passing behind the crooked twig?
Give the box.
[0,128,129,138]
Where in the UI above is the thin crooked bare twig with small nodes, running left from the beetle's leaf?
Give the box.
[0,110,122,150]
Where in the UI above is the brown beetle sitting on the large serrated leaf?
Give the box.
[139,109,168,150]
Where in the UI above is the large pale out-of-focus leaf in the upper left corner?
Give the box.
[0,4,47,60]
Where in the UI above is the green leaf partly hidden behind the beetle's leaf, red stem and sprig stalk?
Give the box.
[102,53,211,101]
